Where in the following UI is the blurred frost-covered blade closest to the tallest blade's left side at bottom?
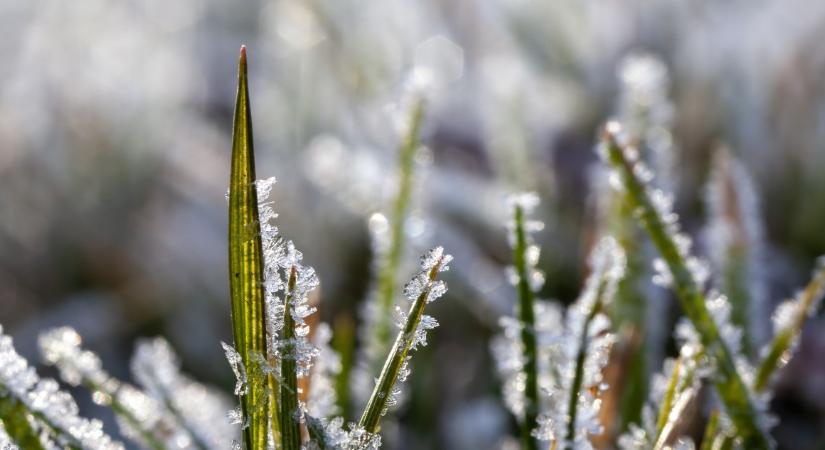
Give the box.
[131,338,237,449]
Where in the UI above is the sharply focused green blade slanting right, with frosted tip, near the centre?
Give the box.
[358,248,452,433]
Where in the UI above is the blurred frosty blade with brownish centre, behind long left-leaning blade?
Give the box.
[705,148,768,345]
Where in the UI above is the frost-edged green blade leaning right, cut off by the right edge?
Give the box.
[754,260,825,392]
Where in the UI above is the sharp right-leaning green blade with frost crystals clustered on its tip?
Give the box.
[358,247,452,433]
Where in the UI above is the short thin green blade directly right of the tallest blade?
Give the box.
[278,266,301,450]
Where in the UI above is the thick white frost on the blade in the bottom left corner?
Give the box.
[0,327,124,450]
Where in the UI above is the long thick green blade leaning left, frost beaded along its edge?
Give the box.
[602,122,772,450]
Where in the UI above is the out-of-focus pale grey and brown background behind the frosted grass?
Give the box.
[0,0,825,449]
